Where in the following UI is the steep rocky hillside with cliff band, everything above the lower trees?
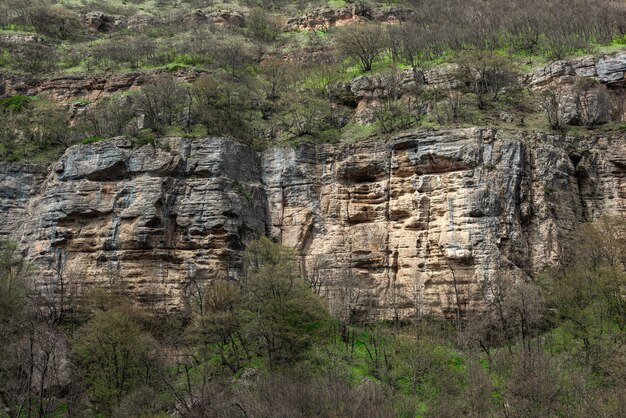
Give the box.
[0,1,626,318]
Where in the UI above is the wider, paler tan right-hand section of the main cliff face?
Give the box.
[263,129,625,317]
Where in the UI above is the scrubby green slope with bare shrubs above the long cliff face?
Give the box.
[0,0,626,160]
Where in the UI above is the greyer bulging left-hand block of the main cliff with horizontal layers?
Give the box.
[22,138,267,309]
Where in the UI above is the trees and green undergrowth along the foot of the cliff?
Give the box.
[0,218,626,417]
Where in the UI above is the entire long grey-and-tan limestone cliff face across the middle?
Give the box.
[0,128,626,317]
